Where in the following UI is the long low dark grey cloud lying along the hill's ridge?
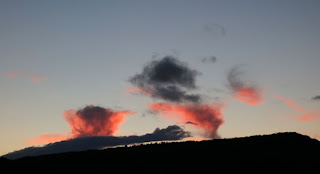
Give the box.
[5,125,190,159]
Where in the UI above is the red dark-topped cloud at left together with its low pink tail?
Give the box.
[26,105,135,145]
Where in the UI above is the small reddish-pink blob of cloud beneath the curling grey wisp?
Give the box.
[233,88,263,105]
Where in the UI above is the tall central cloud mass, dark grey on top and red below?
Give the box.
[127,56,224,138]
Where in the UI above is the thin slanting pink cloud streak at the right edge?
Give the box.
[274,95,320,122]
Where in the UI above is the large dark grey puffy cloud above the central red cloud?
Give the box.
[129,56,201,103]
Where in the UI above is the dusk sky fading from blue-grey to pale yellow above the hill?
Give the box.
[0,0,320,155]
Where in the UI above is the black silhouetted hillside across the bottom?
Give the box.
[0,133,320,173]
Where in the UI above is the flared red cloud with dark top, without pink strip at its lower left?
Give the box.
[63,105,134,137]
